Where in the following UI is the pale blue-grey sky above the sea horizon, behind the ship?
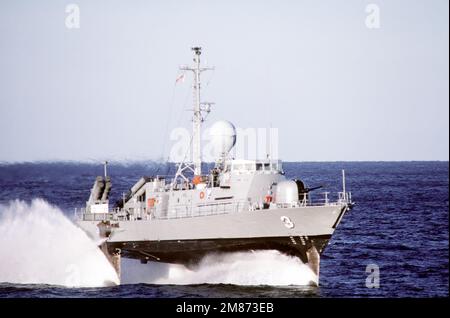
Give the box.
[0,0,449,161]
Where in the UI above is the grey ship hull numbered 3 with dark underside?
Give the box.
[78,204,347,274]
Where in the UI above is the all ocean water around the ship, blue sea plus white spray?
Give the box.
[0,162,449,298]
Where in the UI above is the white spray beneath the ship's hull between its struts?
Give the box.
[122,251,317,286]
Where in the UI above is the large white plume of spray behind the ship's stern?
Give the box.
[0,199,119,287]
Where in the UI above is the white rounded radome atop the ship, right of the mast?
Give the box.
[209,120,236,156]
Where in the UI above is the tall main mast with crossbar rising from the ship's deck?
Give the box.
[180,47,213,176]
